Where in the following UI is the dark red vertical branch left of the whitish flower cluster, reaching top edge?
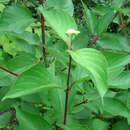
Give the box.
[40,0,46,64]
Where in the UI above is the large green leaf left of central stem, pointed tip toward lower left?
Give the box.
[3,64,60,100]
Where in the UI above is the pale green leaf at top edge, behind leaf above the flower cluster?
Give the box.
[47,0,74,16]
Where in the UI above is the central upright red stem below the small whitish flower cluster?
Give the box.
[63,56,72,125]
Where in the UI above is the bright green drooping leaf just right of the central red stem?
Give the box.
[69,48,107,97]
